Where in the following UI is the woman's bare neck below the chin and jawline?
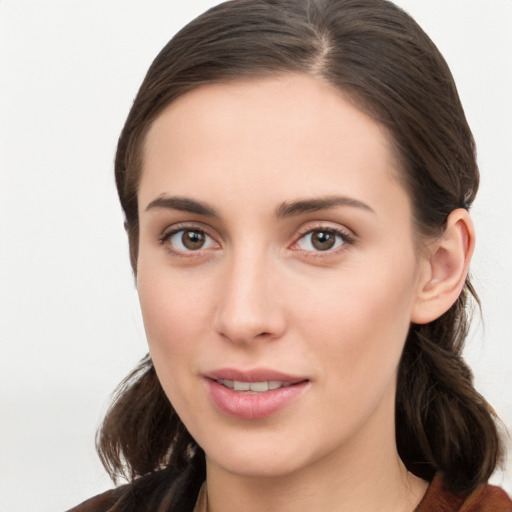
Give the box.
[207,394,427,512]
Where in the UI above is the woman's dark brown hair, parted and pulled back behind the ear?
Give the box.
[97,0,501,491]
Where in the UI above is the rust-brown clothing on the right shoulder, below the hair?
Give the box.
[415,476,512,512]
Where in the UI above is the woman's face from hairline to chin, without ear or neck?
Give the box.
[137,75,424,476]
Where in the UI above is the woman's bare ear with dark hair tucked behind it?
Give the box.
[411,208,475,324]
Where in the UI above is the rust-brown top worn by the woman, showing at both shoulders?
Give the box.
[68,476,512,512]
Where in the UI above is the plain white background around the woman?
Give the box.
[0,0,512,512]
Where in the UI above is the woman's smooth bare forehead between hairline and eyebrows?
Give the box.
[139,75,403,216]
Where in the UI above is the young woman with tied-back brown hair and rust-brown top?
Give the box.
[69,0,512,512]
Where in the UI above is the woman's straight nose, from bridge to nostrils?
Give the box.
[214,248,286,344]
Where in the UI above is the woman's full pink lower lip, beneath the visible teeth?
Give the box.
[207,379,308,420]
